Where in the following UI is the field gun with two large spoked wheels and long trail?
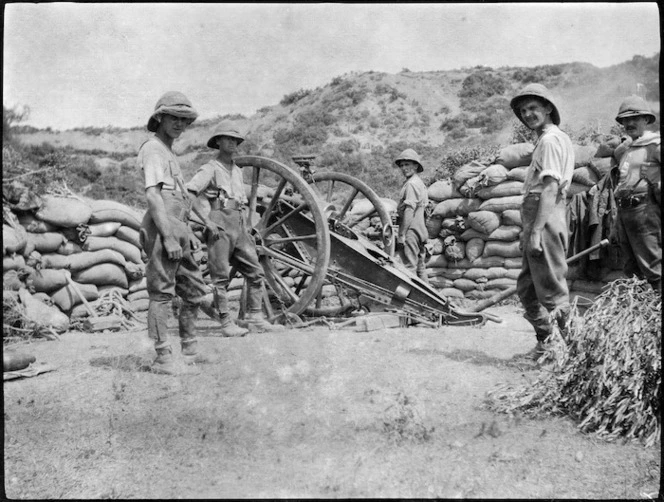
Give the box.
[215,156,501,326]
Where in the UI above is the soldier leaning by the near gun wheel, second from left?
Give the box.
[187,120,283,336]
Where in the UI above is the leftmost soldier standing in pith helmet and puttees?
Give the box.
[137,91,207,374]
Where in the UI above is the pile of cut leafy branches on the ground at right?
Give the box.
[489,278,662,446]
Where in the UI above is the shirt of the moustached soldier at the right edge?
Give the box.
[614,131,662,195]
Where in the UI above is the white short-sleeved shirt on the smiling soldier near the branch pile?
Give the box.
[522,124,574,196]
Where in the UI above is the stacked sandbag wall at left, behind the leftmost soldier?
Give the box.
[3,195,147,317]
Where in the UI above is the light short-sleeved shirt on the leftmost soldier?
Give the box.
[136,136,184,190]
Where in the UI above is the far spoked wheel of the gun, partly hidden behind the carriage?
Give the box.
[311,171,395,256]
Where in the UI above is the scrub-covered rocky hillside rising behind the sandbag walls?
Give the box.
[9,54,659,202]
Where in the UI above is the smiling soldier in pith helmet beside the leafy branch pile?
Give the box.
[510,84,574,360]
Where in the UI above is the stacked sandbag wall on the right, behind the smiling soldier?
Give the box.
[427,139,616,300]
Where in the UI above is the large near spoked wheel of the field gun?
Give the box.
[235,155,330,319]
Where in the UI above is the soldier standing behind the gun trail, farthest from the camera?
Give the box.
[394,148,429,283]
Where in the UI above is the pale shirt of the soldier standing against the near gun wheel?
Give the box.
[186,159,247,204]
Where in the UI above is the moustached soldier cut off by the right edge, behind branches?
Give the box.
[611,96,662,294]
